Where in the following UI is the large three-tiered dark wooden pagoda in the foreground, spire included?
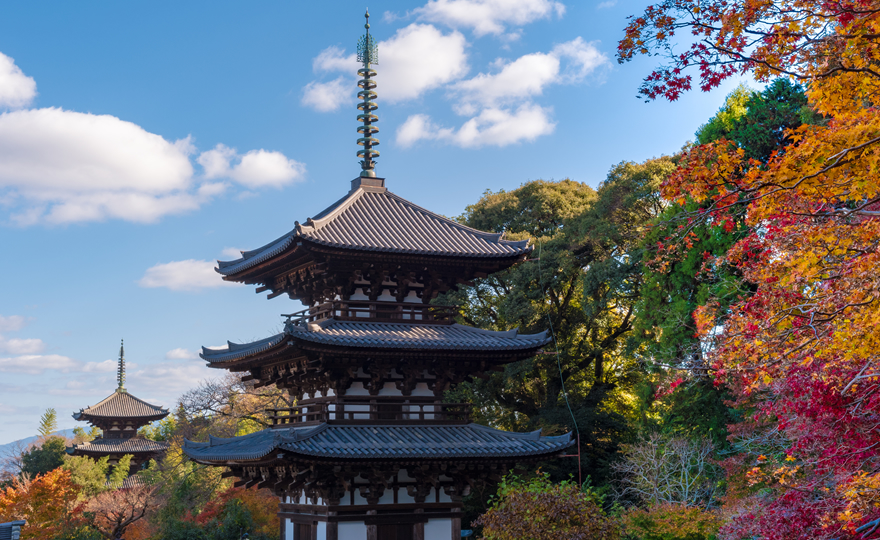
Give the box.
[184,14,572,540]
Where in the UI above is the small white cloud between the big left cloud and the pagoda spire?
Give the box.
[198,144,305,188]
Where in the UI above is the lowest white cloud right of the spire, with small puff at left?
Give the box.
[397,103,556,148]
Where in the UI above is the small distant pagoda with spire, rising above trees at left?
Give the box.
[67,344,168,470]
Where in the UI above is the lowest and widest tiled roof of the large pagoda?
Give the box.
[183,424,573,462]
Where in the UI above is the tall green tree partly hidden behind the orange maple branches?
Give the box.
[633,79,817,447]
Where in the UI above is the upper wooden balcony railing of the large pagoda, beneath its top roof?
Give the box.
[282,300,456,326]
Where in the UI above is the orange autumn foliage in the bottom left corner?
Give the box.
[0,468,84,540]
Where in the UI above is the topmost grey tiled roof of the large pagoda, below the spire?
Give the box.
[216,180,532,277]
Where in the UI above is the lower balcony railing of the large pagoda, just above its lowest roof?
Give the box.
[266,396,472,428]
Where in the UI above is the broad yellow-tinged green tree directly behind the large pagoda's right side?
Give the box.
[438,157,675,482]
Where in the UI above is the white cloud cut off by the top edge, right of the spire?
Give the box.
[412,0,565,36]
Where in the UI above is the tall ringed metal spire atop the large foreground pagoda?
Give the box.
[357,9,379,178]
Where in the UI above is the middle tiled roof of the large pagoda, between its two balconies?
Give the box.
[201,318,551,364]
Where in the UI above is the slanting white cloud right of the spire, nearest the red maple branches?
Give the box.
[450,37,608,108]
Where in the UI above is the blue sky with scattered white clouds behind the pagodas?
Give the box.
[0,0,748,443]
